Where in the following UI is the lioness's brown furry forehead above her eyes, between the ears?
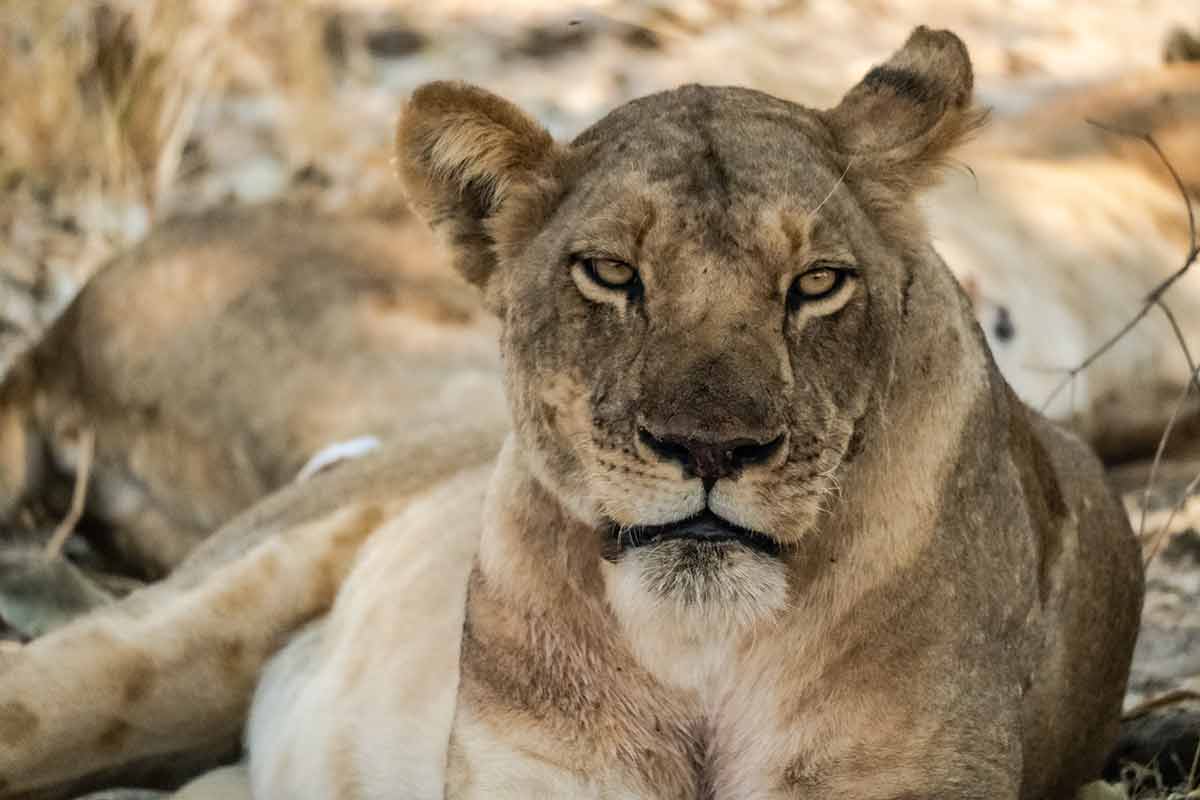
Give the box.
[559,85,851,279]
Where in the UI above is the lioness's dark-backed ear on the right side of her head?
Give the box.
[824,25,988,194]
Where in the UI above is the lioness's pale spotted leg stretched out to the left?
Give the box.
[0,421,504,798]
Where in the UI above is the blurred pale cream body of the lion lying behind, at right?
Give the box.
[924,64,1200,461]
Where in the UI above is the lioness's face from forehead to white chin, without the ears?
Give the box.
[503,86,888,618]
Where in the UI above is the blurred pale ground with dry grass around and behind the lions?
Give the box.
[0,0,1200,800]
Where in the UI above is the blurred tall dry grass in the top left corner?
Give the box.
[0,0,348,375]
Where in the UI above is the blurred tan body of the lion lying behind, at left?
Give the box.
[0,207,499,576]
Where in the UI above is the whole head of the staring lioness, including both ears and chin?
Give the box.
[397,28,982,633]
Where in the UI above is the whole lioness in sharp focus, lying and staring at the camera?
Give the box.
[0,28,1141,800]
